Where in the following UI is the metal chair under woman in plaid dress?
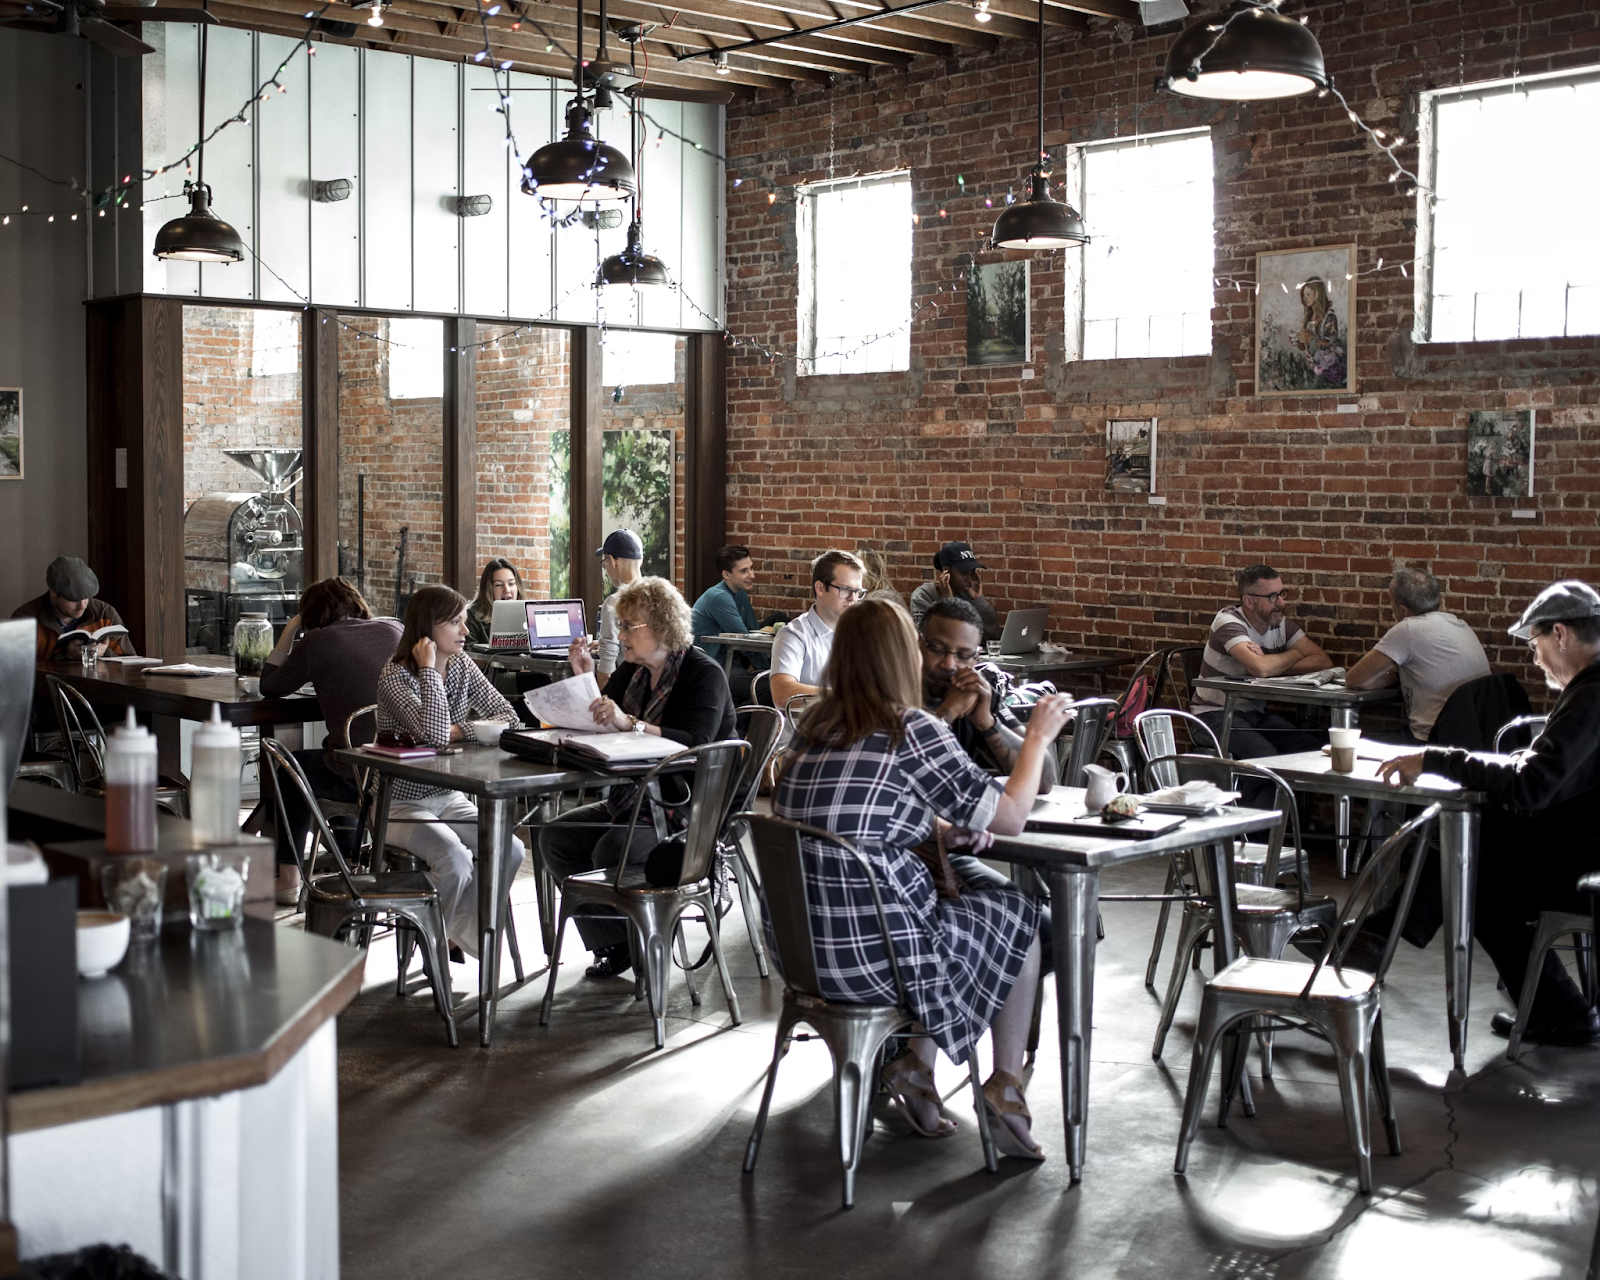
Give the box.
[739,813,1000,1210]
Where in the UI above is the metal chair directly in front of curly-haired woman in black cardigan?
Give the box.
[539,738,750,1050]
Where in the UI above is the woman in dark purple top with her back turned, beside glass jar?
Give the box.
[261,578,400,907]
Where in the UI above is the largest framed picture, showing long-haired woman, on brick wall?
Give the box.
[1256,245,1355,395]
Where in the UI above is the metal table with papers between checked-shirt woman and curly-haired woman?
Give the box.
[333,746,604,1048]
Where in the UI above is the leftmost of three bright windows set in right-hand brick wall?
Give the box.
[798,173,914,374]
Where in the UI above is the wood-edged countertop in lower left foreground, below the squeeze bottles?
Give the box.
[10,920,366,1133]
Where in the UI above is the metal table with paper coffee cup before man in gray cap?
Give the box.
[1251,742,1485,1070]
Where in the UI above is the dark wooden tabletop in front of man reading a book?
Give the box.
[37,653,322,725]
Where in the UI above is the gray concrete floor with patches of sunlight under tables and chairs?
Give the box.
[339,864,1600,1280]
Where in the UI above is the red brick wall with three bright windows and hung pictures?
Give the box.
[726,0,1600,700]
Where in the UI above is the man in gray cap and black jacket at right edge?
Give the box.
[1381,581,1600,1045]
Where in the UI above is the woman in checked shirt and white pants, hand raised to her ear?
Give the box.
[378,586,523,955]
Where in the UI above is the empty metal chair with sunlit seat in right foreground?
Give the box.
[1173,805,1440,1194]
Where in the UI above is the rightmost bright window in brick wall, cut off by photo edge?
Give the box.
[1416,70,1600,342]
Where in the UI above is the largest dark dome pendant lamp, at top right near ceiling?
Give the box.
[1163,0,1328,102]
